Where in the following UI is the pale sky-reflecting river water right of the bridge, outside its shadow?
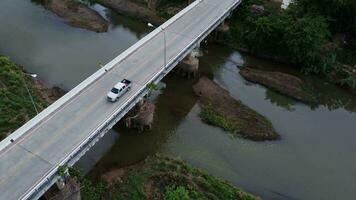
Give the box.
[164,45,356,200]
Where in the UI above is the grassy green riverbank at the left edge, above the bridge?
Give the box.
[0,56,64,139]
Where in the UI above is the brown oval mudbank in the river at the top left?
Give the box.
[40,0,109,33]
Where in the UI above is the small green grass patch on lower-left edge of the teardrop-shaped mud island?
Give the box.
[199,105,235,132]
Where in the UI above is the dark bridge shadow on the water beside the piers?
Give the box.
[88,73,197,178]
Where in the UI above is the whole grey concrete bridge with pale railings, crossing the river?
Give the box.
[0,0,241,200]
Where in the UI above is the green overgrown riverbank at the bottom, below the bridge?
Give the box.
[76,156,259,200]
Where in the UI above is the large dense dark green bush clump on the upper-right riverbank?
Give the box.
[229,0,336,74]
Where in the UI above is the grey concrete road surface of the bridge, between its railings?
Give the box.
[0,0,238,200]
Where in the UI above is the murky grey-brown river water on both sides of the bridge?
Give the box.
[0,0,356,200]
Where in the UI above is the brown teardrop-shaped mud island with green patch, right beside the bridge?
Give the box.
[193,77,279,140]
